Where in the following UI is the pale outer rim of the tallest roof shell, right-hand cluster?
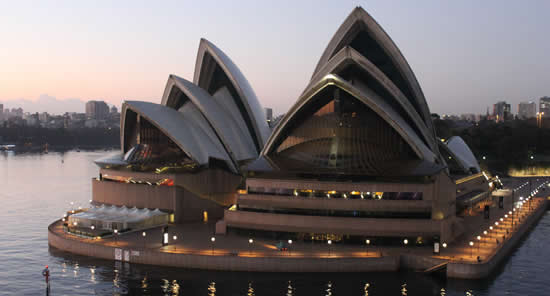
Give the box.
[312,6,437,141]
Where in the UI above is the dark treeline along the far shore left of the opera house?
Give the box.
[0,126,120,149]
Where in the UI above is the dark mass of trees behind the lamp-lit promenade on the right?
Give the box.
[434,119,550,174]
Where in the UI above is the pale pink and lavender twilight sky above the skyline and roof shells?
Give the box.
[0,0,550,114]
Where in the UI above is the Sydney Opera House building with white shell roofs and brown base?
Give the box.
[93,7,489,243]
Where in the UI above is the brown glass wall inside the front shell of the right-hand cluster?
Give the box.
[269,86,417,175]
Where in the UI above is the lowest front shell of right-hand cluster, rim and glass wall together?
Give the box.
[262,75,435,175]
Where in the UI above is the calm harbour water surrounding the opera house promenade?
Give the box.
[0,151,550,296]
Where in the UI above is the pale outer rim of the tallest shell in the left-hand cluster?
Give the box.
[193,38,270,150]
